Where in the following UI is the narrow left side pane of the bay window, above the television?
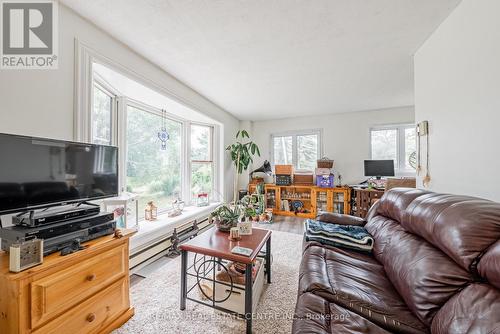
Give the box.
[92,85,113,145]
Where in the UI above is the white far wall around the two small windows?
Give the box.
[240,107,414,188]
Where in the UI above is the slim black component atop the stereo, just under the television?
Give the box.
[12,204,100,227]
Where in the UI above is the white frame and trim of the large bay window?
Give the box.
[74,39,221,204]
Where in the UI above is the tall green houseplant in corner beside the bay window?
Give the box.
[226,130,260,202]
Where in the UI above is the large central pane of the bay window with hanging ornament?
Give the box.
[127,106,182,218]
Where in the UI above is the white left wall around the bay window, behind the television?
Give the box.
[0,4,239,204]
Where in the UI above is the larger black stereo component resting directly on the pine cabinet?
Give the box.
[0,213,116,255]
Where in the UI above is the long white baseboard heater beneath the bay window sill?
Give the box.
[130,218,212,275]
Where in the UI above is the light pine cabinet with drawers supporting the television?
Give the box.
[0,233,134,334]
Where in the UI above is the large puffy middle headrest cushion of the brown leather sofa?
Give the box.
[401,193,500,274]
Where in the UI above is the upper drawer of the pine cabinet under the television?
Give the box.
[31,245,128,328]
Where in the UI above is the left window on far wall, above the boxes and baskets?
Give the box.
[271,130,321,171]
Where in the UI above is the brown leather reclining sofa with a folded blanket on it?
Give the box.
[293,188,500,334]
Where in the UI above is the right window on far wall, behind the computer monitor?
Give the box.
[370,124,417,175]
